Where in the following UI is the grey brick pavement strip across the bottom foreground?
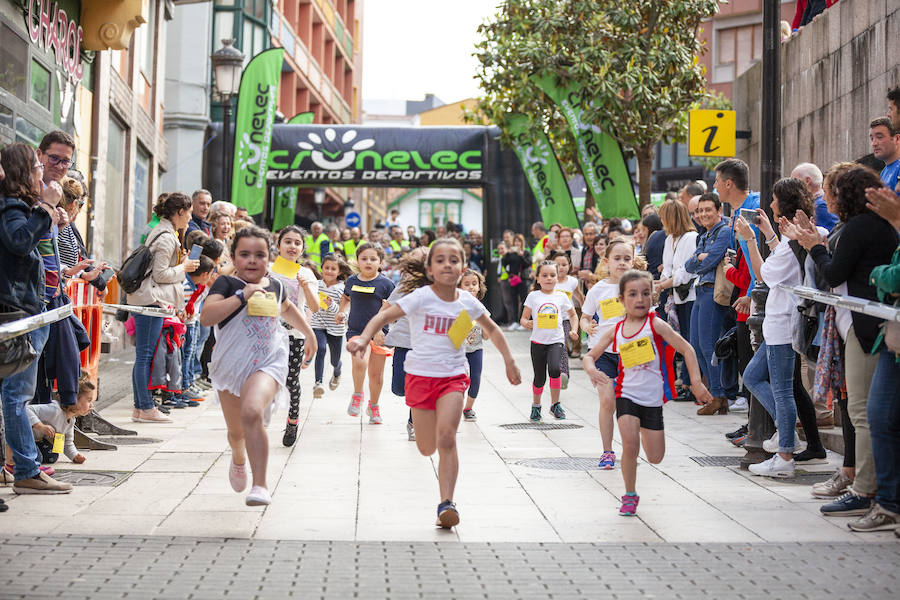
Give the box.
[0,536,900,600]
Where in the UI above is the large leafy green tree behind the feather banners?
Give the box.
[475,0,720,207]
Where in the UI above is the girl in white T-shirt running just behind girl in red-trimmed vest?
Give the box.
[581,238,647,471]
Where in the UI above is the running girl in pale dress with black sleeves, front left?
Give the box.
[200,226,316,506]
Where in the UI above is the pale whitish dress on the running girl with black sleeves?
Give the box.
[209,278,288,396]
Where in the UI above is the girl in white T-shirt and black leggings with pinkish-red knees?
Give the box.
[521,260,578,421]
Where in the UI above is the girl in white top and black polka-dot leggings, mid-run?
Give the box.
[269,225,319,447]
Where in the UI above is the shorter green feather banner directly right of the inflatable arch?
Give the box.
[506,113,578,227]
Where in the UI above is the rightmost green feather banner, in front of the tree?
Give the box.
[531,75,641,219]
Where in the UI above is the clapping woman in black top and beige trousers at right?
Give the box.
[798,167,898,516]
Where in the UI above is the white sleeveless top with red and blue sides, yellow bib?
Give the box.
[613,312,669,406]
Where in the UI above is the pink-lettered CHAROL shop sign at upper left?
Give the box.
[26,0,84,84]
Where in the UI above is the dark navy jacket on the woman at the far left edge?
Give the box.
[0,196,53,315]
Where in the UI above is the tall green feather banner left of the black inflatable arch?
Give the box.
[232,48,284,215]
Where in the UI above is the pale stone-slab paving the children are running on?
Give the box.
[0,333,896,548]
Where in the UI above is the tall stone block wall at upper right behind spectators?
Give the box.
[733,0,900,189]
